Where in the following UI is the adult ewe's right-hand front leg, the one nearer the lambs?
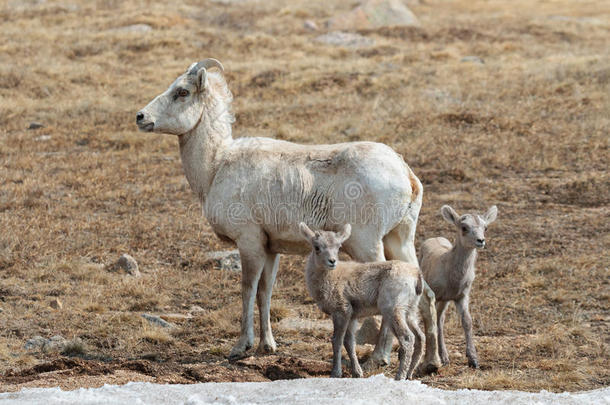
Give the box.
[256,253,280,353]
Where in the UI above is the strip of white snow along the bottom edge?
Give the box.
[0,375,610,405]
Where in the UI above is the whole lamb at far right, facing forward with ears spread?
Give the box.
[419,205,498,368]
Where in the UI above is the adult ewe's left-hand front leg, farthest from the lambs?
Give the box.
[229,241,266,360]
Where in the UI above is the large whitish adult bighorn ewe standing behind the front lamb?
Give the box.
[136,59,440,370]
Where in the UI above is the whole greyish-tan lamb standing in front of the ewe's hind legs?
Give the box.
[299,222,424,380]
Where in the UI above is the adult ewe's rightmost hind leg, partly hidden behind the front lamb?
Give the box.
[383,222,441,374]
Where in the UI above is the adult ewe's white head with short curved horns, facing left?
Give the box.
[136,58,231,135]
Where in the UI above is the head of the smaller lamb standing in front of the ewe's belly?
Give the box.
[299,222,352,270]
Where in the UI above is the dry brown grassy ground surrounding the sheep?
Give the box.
[0,0,610,391]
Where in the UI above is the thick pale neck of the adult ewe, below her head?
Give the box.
[179,104,233,202]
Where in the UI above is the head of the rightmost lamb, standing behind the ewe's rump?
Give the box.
[441,205,498,248]
